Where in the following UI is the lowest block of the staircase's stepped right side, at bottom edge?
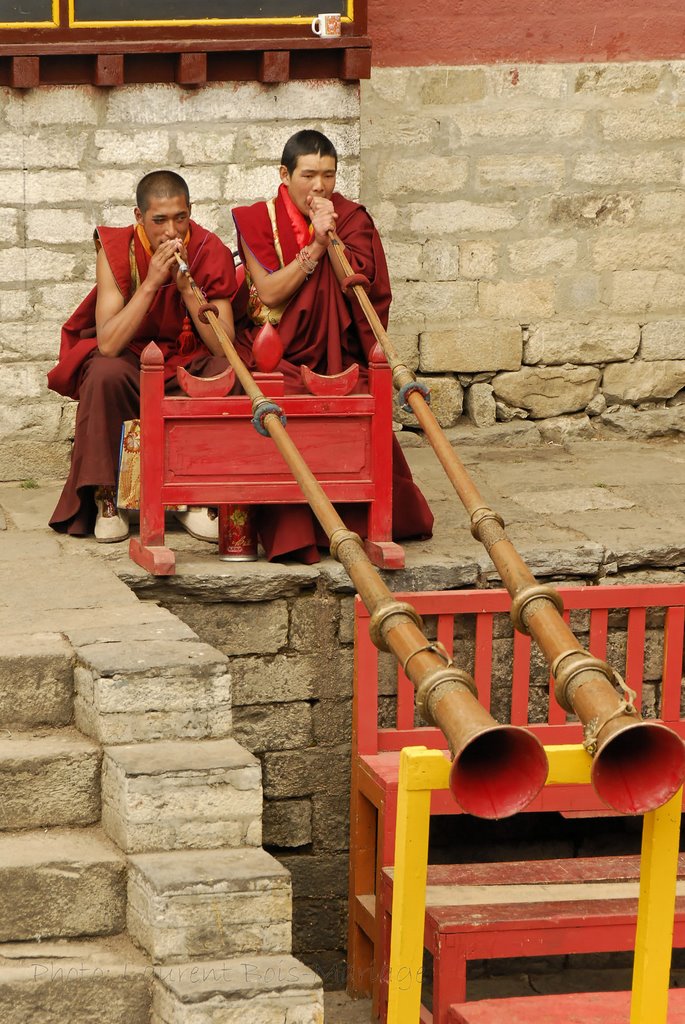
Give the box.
[152,956,324,1024]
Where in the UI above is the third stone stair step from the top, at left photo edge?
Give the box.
[0,828,126,942]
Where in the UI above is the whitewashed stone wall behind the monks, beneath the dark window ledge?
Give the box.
[0,82,359,480]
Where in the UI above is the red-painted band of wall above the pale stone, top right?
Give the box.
[369,0,685,68]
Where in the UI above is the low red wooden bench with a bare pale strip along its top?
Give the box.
[380,854,685,1024]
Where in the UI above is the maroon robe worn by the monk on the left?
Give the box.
[48,221,237,536]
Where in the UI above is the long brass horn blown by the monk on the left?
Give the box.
[177,257,548,818]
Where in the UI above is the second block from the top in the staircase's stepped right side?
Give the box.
[102,739,262,853]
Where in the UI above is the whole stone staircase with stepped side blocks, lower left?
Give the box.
[0,578,324,1024]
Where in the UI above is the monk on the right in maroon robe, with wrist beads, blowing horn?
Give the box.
[232,131,433,562]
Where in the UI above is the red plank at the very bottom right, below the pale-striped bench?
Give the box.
[447,988,685,1024]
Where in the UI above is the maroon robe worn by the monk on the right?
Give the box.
[232,186,433,562]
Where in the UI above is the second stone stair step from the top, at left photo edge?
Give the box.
[0,728,101,831]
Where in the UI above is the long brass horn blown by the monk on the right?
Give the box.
[329,241,685,814]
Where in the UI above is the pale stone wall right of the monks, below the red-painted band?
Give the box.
[361,62,685,435]
